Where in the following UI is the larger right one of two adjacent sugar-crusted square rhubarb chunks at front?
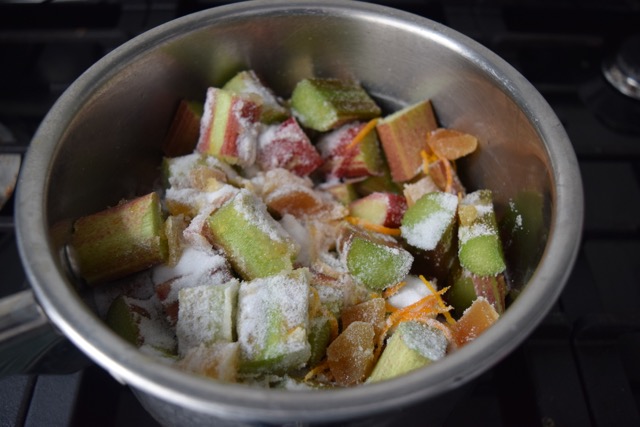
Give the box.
[237,269,311,372]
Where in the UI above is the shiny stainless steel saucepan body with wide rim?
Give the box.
[16,0,583,425]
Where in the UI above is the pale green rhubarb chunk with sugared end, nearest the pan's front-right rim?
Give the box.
[367,321,449,382]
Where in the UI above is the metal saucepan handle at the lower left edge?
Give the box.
[0,289,87,377]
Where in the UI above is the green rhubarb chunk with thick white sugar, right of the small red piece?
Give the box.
[400,192,458,251]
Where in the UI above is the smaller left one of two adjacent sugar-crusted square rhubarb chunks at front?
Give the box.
[176,279,240,355]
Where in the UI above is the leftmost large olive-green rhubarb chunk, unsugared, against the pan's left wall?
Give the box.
[70,192,168,285]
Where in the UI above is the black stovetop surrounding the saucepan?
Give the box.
[0,0,640,427]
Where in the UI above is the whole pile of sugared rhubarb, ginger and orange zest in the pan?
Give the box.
[70,71,507,388]
